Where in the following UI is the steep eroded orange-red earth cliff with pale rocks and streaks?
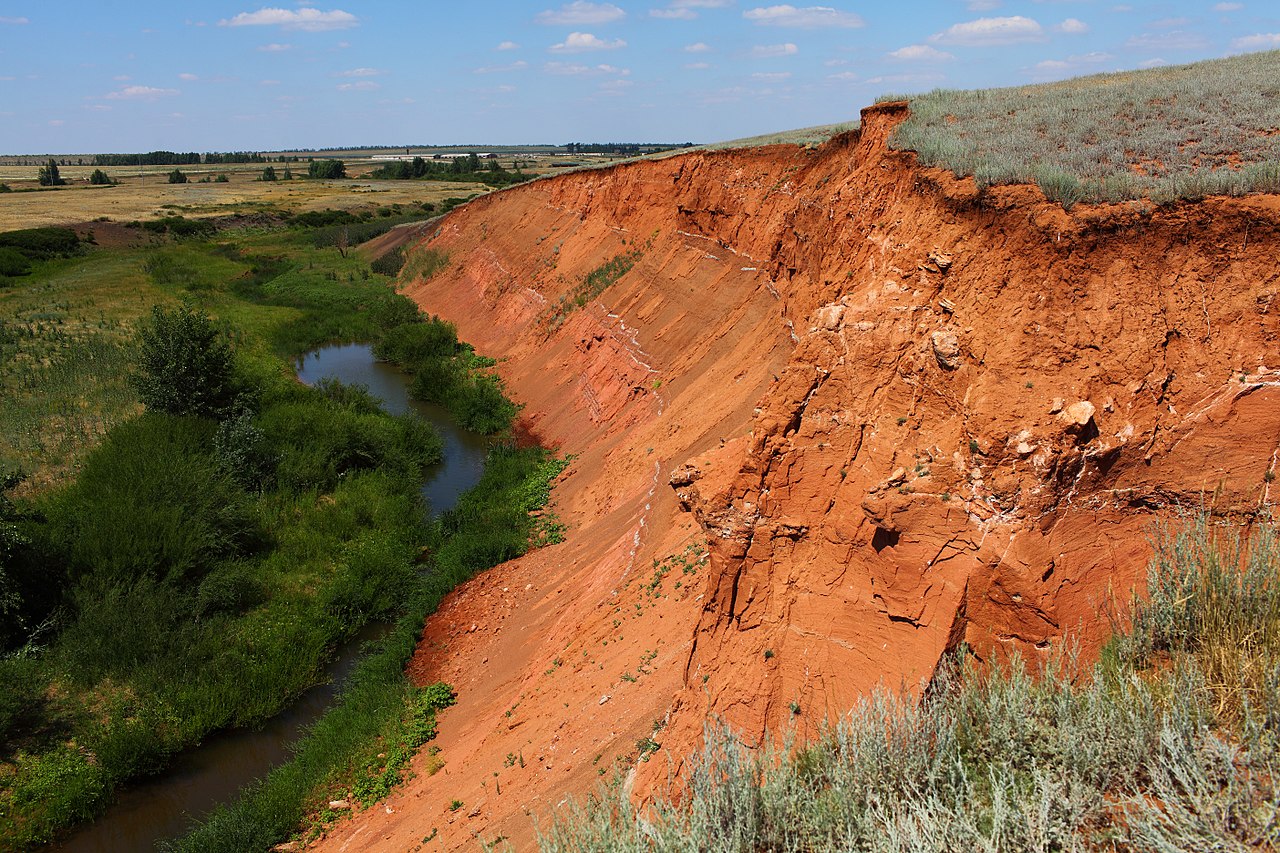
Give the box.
[307,105,1280,850]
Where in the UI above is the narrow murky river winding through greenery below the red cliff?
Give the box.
[52,343,488,853]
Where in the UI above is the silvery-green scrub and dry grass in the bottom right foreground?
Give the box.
[541,519,1280,852]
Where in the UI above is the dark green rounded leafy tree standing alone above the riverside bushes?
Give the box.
[132,305,234,416]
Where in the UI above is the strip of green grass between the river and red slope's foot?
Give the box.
[168,443,567,853]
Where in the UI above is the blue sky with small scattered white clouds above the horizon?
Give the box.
[0,0,1280,154]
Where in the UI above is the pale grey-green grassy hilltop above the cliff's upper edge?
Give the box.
[879,51,1280,209]
